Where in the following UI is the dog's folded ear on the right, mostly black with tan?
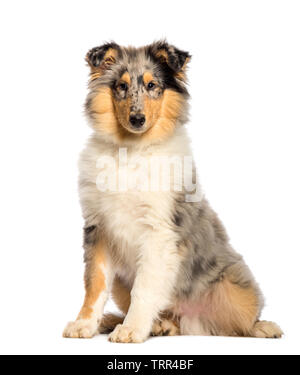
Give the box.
[149,40,191,79]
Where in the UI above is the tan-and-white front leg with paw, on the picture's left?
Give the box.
[63,236,113,338]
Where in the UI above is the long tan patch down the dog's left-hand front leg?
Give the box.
[77,242,106,319]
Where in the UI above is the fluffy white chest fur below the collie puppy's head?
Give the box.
[80,132,189,274]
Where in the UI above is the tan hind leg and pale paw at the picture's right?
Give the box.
[180,275,283,338]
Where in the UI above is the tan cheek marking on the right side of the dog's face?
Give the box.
[143,89,184,141]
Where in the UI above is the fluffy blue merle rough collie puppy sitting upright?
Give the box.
[63,41,282,342]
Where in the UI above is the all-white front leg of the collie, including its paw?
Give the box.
[109,238,179,342]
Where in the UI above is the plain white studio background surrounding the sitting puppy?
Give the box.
[0,0,300,354]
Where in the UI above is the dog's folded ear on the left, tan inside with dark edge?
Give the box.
[85,42,121,80]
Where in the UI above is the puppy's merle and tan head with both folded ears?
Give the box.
[86,41,190,143]
